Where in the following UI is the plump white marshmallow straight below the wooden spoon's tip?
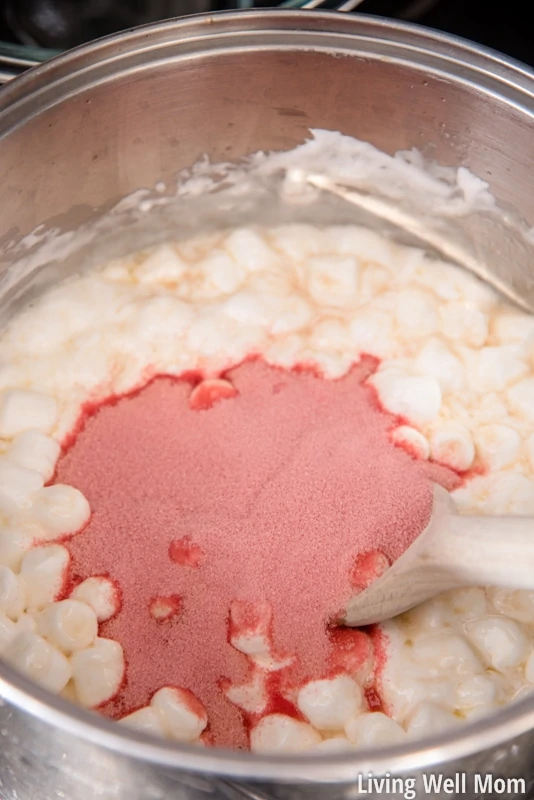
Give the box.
[297,675,363,731]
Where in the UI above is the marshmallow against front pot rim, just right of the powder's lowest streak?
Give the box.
[250,714,322,754]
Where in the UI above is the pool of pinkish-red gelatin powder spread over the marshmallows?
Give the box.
[57,361,456,747]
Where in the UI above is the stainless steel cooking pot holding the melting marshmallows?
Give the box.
[0,11,534,800]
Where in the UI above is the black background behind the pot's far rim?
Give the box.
[0,0,534,66]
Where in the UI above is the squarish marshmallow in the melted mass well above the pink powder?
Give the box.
[306,255,359,308]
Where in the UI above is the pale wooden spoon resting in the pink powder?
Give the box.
[339,485,534,626]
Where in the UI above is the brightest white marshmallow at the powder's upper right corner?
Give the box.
[369,369,441,425]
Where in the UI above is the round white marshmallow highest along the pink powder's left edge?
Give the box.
[32,483,91,539]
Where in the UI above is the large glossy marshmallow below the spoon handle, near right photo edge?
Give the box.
[465,617,527,671]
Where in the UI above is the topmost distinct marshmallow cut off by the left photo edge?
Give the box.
[0,389,58,439]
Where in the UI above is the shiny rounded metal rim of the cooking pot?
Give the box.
[0,9,534,783]
